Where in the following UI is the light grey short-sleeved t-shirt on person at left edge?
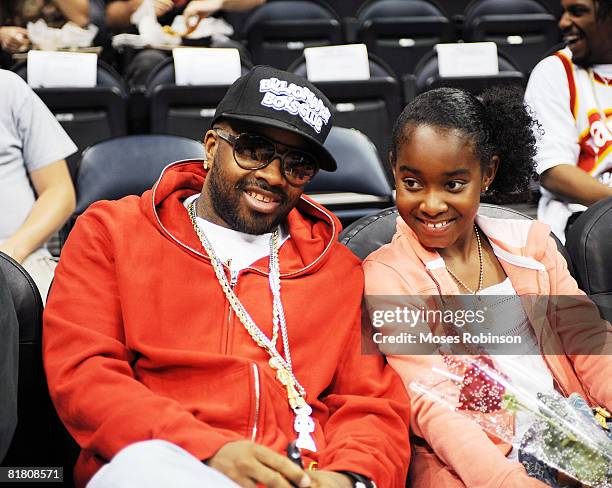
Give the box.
[0,69,77,242]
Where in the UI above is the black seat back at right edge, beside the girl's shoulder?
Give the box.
[566,198,612,321]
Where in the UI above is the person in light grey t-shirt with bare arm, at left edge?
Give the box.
[0,70,77,303]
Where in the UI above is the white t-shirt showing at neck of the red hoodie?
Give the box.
[183,194,289,276]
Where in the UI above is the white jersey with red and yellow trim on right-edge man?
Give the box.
[525,49,612,242]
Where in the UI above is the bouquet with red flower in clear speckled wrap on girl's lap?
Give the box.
[410,356,612,488]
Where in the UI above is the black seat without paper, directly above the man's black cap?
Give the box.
[241,0,343,69]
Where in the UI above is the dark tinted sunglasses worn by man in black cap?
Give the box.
[214,129,319,186]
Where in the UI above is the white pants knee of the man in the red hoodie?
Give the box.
[87,440,239,488]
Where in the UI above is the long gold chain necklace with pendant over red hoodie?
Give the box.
[188,200,317,452]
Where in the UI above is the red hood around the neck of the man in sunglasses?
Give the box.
[140,159,342,277]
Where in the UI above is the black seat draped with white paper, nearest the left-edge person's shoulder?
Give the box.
[13,60,128,179]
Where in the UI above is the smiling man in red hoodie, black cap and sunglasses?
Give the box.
[44,66,410,488]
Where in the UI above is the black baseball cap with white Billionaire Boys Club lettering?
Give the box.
[211,66,336,171]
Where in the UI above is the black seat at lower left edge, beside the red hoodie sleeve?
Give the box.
[0,252,78,486]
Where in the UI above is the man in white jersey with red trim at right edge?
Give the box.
[525,0,612,242]
